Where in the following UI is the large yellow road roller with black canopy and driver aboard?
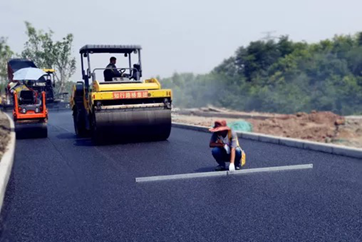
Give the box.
[70,45,172,144]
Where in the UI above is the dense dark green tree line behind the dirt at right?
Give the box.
[161,32,362,115]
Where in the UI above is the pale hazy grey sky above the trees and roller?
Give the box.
[0,0,362,78]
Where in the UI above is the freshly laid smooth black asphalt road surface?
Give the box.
[1,112,362,241]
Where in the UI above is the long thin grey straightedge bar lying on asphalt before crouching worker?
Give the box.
[136,164,313,183]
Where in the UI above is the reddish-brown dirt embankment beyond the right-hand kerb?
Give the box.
[173,107,362,148]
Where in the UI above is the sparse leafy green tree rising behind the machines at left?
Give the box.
[22,22,76,93]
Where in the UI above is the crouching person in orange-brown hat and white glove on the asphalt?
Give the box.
[209,120,245,171]
